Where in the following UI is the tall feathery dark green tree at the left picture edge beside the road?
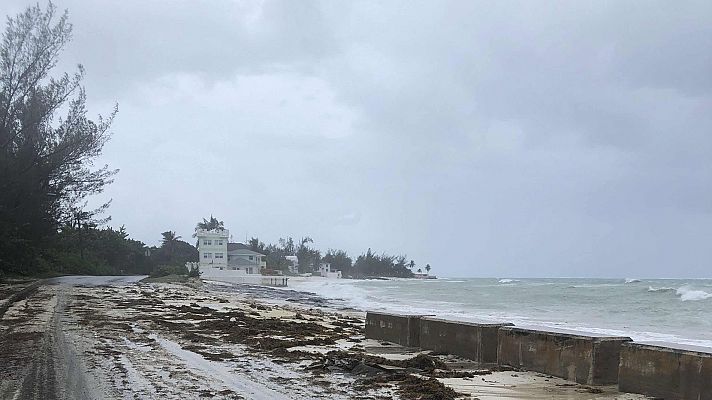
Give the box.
[0,3,116,274]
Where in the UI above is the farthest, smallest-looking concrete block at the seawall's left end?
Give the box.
[366,311,421,347]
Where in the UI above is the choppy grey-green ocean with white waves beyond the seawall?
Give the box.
[289,278,712,348]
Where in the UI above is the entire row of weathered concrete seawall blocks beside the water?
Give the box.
[366,312,712,394]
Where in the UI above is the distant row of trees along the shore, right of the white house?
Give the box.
[248,236,430,278]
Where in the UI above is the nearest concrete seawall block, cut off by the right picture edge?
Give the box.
[618,343,712,400]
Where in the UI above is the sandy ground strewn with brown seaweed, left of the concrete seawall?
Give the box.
[0,277,644,399]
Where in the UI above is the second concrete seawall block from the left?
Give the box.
[420,317,512,363]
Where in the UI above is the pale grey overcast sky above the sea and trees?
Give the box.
[0,0,712,277]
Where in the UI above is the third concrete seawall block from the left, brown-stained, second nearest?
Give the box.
[497,327,631,385]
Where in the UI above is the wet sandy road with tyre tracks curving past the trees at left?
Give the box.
[0,276,143,399]
